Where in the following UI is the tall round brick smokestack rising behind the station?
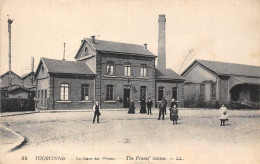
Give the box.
[157,14,166,70]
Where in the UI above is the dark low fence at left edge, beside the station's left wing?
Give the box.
[0,98,35,113]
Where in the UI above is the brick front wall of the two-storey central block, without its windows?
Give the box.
[96,54,155,108]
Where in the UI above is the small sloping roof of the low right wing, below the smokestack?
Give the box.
[155,68,185,81]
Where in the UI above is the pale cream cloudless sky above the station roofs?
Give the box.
[0,0,260,75]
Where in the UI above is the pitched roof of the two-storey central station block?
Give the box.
[75,38,156,58]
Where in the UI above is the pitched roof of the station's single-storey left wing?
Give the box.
[41,58,95,75]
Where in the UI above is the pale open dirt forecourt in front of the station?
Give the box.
[1,109,260,164]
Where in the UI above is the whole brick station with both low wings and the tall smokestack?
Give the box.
[36,15,184,109]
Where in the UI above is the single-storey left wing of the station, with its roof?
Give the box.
[36,58,95,110]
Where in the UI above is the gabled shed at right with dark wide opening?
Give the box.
[181,60,260,108]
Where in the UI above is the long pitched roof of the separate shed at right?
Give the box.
[181,60,260,77]
